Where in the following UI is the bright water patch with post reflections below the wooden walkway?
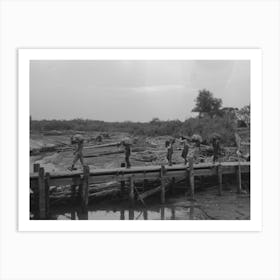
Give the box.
[51,204,203,220]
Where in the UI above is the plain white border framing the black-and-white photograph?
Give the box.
[18,49,262,231]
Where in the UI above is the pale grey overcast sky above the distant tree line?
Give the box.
[30,60,250,122]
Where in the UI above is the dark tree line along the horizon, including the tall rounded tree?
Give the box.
[30,89,250,145]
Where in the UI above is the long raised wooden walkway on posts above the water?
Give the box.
[30,162,250,219]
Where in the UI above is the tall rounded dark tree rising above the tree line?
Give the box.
[192,89,222,118]
